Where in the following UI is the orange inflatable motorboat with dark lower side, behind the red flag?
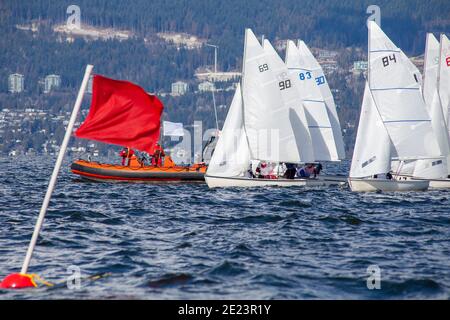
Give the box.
[70,157,207,182]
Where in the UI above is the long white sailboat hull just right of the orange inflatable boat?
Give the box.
[205,175,346,188]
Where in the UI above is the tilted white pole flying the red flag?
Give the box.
[20,64,94,274]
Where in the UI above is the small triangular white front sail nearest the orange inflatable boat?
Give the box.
[207,85,250,177]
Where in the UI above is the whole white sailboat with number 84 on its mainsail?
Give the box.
[349,21,441,192]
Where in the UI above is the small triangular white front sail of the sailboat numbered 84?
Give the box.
[350,83,392,178]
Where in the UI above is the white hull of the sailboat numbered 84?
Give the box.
[348,178,429,192]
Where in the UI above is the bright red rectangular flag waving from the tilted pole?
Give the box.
[75,75,164,153]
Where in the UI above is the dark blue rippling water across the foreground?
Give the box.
[0,157,450,299]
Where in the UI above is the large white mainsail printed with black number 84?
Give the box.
[368,21,441,159]
